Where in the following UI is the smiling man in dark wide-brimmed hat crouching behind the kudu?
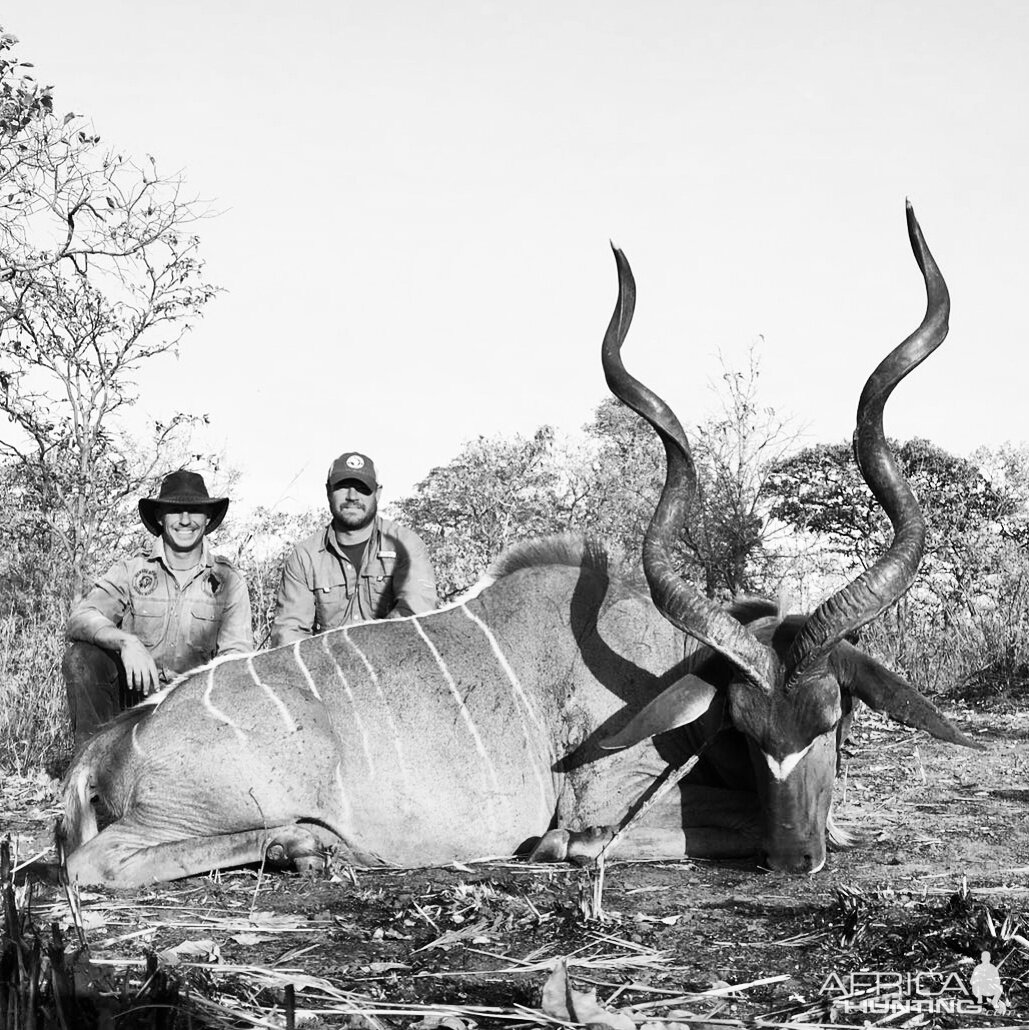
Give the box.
[64,471,253,745]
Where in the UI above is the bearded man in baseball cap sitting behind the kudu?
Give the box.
[272,451,436,647]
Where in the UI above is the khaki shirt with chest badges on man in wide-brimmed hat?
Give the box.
[65,537,253,683]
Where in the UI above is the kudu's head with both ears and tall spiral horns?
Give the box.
[603,204,975,872]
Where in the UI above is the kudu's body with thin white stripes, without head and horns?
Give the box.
[65,539,758,886]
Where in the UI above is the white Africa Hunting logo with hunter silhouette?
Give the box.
[820,952,1007,1016]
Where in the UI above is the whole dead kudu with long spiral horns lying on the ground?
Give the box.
[56,202,970,886]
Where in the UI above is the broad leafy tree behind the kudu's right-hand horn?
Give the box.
[767,439,1029,689]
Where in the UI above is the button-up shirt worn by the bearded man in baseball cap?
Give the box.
[272,516,437,647]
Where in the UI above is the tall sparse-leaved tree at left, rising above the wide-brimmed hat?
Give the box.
[0,34,214,595]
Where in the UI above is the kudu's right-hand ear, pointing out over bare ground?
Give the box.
[829,641,983,751]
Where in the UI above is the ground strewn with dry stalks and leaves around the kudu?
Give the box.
[0,708,1029,1030]
